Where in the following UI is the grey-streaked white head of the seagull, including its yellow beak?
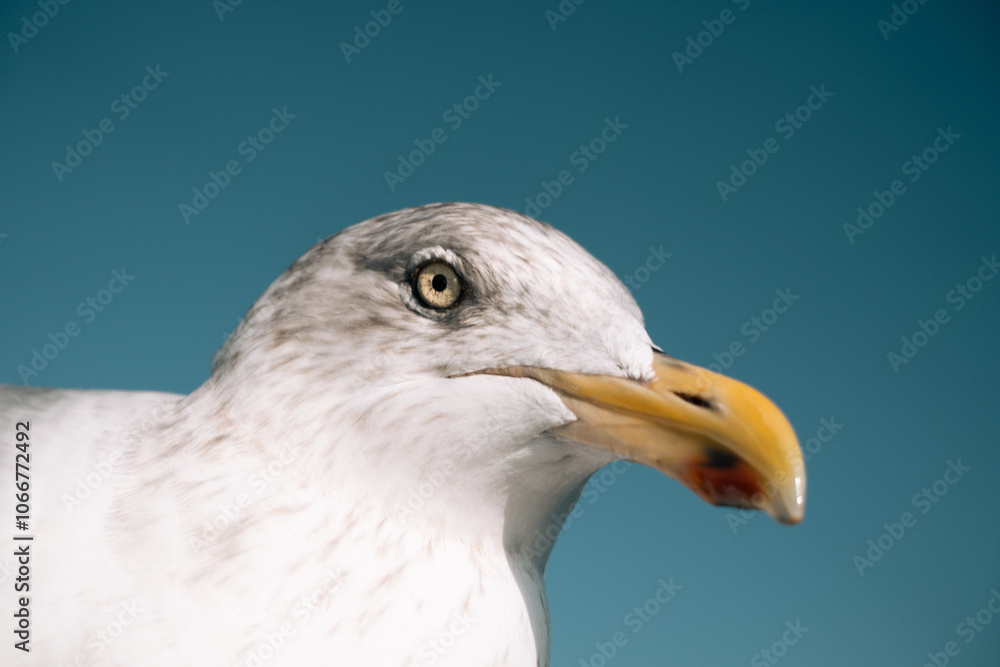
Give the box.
[212,204,805,560]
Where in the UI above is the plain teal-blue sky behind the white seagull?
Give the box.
[0,0,1000,667]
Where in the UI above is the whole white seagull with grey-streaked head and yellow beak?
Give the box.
[0,203,805,667]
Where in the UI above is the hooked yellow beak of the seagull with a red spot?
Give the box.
[487,352,806,524]
